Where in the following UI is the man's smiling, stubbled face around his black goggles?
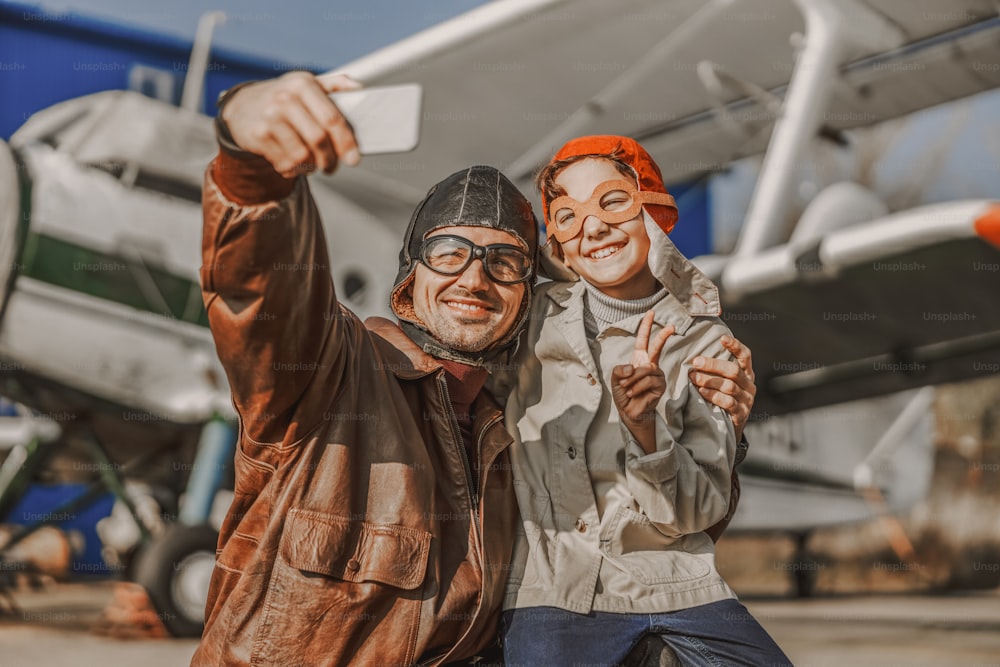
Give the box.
[413,226,528,352]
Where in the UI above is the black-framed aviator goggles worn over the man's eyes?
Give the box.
[420,234,531,285]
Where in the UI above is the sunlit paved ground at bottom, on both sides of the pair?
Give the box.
[0,583,1000,667]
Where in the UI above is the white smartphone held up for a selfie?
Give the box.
[330,83,423,155]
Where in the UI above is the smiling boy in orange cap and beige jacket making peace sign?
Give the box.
[501,136,789,665]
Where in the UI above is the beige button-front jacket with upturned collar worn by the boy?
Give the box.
[504,215,736,613]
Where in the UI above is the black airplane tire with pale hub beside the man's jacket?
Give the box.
[135,523,219,637]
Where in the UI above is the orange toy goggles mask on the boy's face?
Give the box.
[545,180,677,243]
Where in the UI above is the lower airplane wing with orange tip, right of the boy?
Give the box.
[722,201,1000,414]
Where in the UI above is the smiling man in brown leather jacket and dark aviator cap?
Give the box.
[192,73,753,665]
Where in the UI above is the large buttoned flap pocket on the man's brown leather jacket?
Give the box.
[252,509,431,665]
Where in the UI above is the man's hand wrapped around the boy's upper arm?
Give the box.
[689,336,757,439]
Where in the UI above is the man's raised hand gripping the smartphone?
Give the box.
[220,72,361,178]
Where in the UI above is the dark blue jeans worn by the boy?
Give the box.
[500,599,792,667]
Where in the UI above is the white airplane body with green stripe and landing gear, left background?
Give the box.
[0,11,412,636]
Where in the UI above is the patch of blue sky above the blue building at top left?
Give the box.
[20,0,487,69]
